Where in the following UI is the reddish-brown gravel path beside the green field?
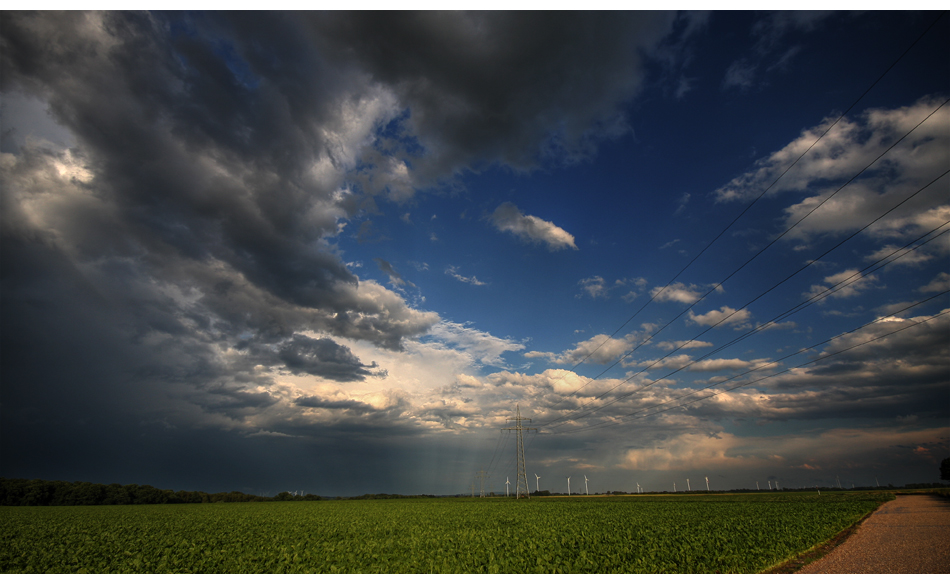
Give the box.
[796,495,950,574]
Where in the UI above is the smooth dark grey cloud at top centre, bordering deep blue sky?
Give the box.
[309,12,674,182]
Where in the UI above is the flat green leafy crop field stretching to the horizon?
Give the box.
[0,492,892,574]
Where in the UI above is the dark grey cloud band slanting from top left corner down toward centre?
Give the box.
[3,13,354,308]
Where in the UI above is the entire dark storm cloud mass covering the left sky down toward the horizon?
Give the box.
[0,12,692,488]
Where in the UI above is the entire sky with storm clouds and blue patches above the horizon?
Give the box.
[0,11,950,496]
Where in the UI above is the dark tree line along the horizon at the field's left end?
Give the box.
[0,477,306,506]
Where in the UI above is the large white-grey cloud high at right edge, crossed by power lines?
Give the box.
[716,97,950,240]
